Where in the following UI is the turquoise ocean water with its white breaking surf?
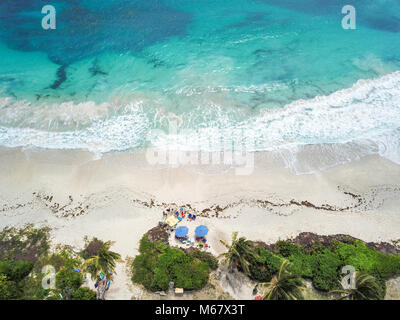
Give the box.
[0,0,400,172]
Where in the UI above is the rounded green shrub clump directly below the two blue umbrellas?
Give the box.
[132,234,218,291]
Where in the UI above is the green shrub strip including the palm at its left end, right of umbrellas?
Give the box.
[223,233,400,299]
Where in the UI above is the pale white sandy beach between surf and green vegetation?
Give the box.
[0,148,400,299]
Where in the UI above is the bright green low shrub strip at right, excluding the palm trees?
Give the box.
[249,240,400,298]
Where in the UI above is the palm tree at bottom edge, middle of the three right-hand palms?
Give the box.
[261,260,304,300]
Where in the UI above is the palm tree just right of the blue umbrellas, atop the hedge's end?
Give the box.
[219,232,256,274]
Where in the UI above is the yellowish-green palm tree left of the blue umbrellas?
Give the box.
[84,241,123,279]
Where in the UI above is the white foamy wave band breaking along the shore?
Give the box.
[0,72,400,172]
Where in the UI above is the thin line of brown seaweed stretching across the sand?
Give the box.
[0,186,400,219]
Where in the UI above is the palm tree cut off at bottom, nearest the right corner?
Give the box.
[330,272,382,300]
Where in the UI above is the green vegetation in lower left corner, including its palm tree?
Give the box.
[0,225,120,300]
